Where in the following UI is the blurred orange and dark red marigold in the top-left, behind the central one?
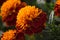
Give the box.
[1,0,27,26]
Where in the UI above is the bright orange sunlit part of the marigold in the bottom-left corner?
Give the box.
[1,30,16,40]
